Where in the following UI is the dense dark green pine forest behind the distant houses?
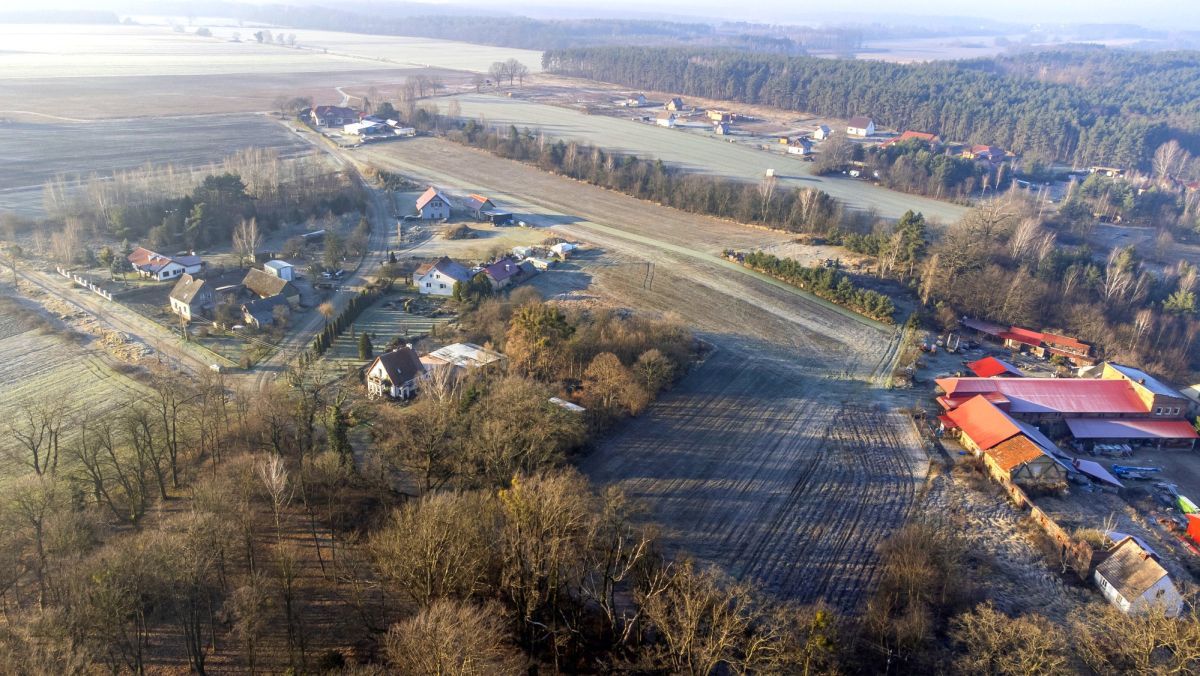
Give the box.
[542,47,1200,168]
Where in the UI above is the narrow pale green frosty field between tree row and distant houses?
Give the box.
[436,94,966,223]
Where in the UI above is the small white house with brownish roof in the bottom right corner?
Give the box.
[1093,537,1183,617]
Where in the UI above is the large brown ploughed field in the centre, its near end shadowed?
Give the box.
[356,139,928,609]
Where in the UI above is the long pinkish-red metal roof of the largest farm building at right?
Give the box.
[936,378,1148,414]
